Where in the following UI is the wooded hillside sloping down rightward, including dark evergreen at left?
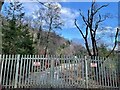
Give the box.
[1,2,85,55]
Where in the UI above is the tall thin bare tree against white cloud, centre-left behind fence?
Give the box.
[45,4,63,55]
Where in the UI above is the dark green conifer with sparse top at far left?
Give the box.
[2,2,34,54]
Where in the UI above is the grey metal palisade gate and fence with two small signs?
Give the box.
[0,55,119,88]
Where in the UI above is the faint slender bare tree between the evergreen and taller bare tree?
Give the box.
[33,8,46,54]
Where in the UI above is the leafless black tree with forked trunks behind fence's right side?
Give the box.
[74,2,119,57]
